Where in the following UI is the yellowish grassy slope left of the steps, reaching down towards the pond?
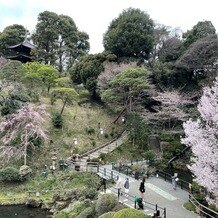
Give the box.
[0,91,122,203]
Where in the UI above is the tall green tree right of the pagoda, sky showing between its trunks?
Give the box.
[32,11,89,72]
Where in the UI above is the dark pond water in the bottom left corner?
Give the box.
[0,205,50,218]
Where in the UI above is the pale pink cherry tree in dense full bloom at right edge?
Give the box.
[181,77,218,205]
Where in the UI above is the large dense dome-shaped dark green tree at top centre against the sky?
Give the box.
[103,8,154,59]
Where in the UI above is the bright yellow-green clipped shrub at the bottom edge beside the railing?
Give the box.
[113,208,151,218]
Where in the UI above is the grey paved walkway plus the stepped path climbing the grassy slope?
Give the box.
[70,132,200,218]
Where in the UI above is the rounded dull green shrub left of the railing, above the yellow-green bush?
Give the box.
[95,194,118,215]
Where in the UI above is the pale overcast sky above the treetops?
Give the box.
[0,0,218,53]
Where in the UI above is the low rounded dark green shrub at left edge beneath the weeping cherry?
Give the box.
[0,167,20,182]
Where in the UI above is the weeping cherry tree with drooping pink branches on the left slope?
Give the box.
[0,104,47,165]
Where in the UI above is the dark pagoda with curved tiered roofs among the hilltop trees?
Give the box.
[7,40,36,63]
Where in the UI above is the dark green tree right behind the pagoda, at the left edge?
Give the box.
[0,24,27,56]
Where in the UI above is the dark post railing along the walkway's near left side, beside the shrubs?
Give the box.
[97,166,166,218]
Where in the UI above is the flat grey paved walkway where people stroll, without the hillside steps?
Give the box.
[100,165,199,218]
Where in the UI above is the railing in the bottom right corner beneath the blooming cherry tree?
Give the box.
[189,194,218,218]
